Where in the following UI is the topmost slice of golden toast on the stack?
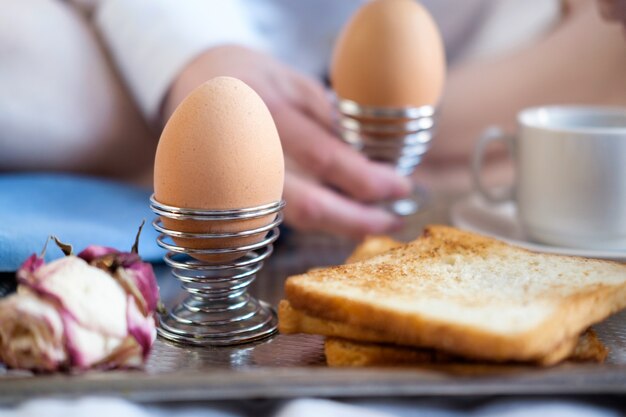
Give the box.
[285,226,626,362]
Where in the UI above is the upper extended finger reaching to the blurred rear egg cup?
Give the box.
[274,106,411,201]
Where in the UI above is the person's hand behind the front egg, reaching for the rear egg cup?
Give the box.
[163,46,411,237]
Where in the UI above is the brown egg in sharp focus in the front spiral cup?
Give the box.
[154,77,284,262]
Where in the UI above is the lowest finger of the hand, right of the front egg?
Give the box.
[284,173,403,238]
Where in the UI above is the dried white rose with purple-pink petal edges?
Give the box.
[0,228,159,371]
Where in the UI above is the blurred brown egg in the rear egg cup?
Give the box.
[330,0,445,107]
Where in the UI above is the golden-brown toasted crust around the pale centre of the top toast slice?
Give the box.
[285,226,626,363]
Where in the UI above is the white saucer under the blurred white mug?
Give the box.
[450,194,626,262]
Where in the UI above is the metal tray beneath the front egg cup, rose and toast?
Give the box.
[0,207,626,403]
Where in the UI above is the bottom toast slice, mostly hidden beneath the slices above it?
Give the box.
[324,329,608,367]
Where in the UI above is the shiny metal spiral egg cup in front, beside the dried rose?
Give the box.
[150,196,285,346]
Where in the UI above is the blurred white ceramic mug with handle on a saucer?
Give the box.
[472,106,626,251]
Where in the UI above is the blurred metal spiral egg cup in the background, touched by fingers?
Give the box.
[335,97,436,215]
